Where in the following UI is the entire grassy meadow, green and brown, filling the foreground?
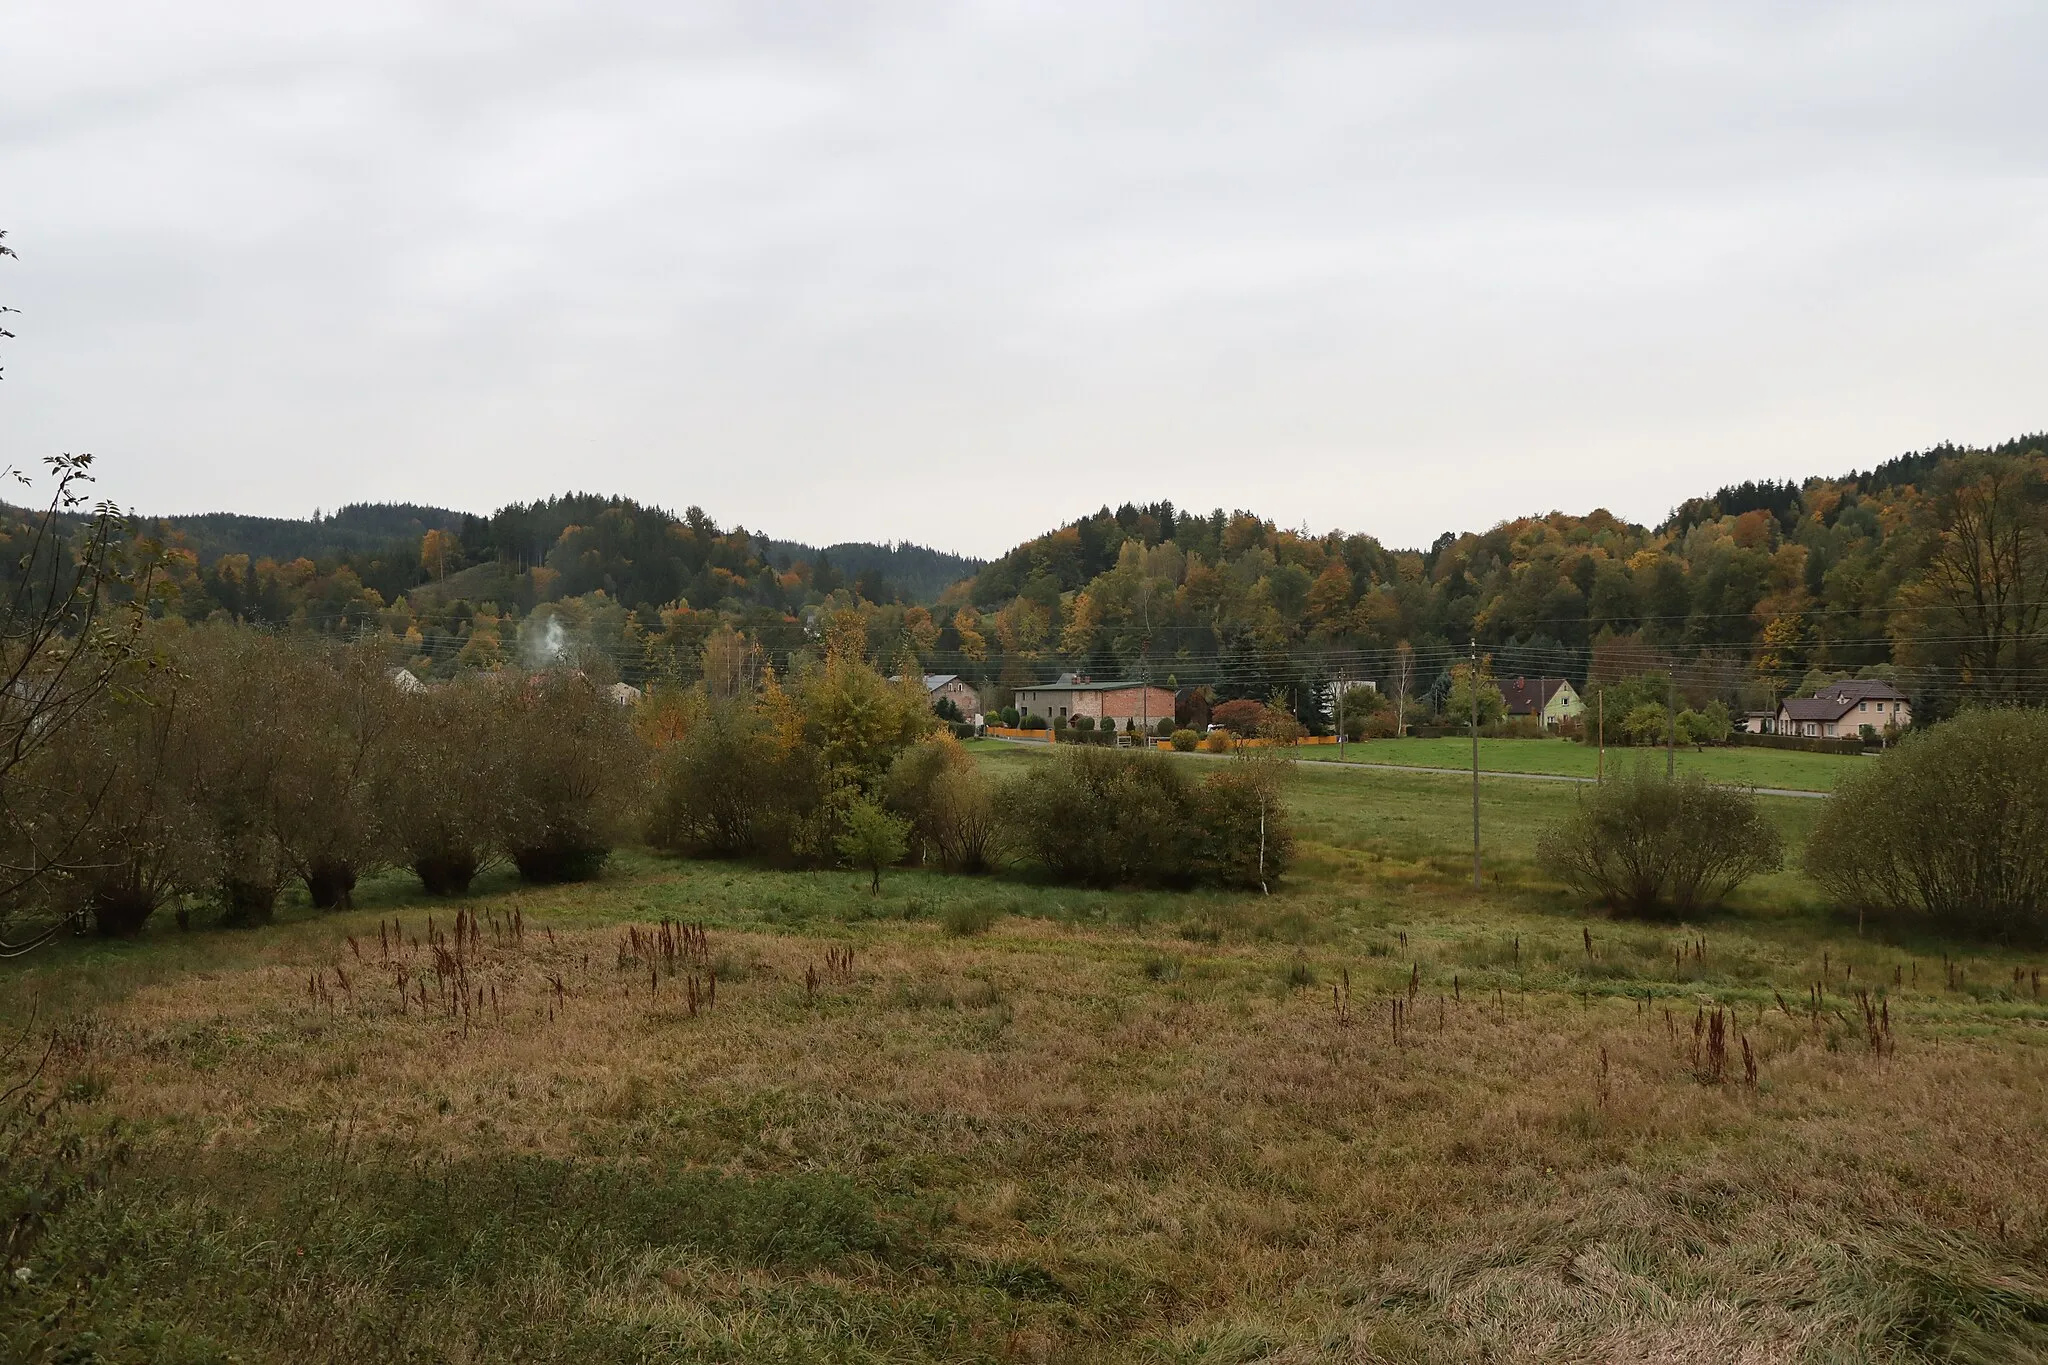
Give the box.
[0,741,2048,1365]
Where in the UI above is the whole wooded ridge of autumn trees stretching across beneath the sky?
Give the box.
[24,436,2048,714]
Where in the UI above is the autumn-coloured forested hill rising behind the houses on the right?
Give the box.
[958,436,2048,718]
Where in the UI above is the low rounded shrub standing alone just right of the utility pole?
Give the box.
[1536,765,1784,915]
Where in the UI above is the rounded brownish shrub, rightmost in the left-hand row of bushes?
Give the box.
[498,671,645,882]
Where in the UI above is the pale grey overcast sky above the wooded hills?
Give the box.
[0,0,2048,555]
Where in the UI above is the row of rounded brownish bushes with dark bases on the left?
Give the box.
[8,624,643,933]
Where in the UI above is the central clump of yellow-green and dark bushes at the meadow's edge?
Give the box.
[649,663,1292,886]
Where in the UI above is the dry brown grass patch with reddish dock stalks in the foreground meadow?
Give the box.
[16,871,2048,1361]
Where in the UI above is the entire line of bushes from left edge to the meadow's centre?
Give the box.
[4,624,1290,935]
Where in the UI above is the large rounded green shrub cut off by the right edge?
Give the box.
[1806,710,2048,939]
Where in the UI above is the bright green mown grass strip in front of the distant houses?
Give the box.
[1300,739,1872,792]
